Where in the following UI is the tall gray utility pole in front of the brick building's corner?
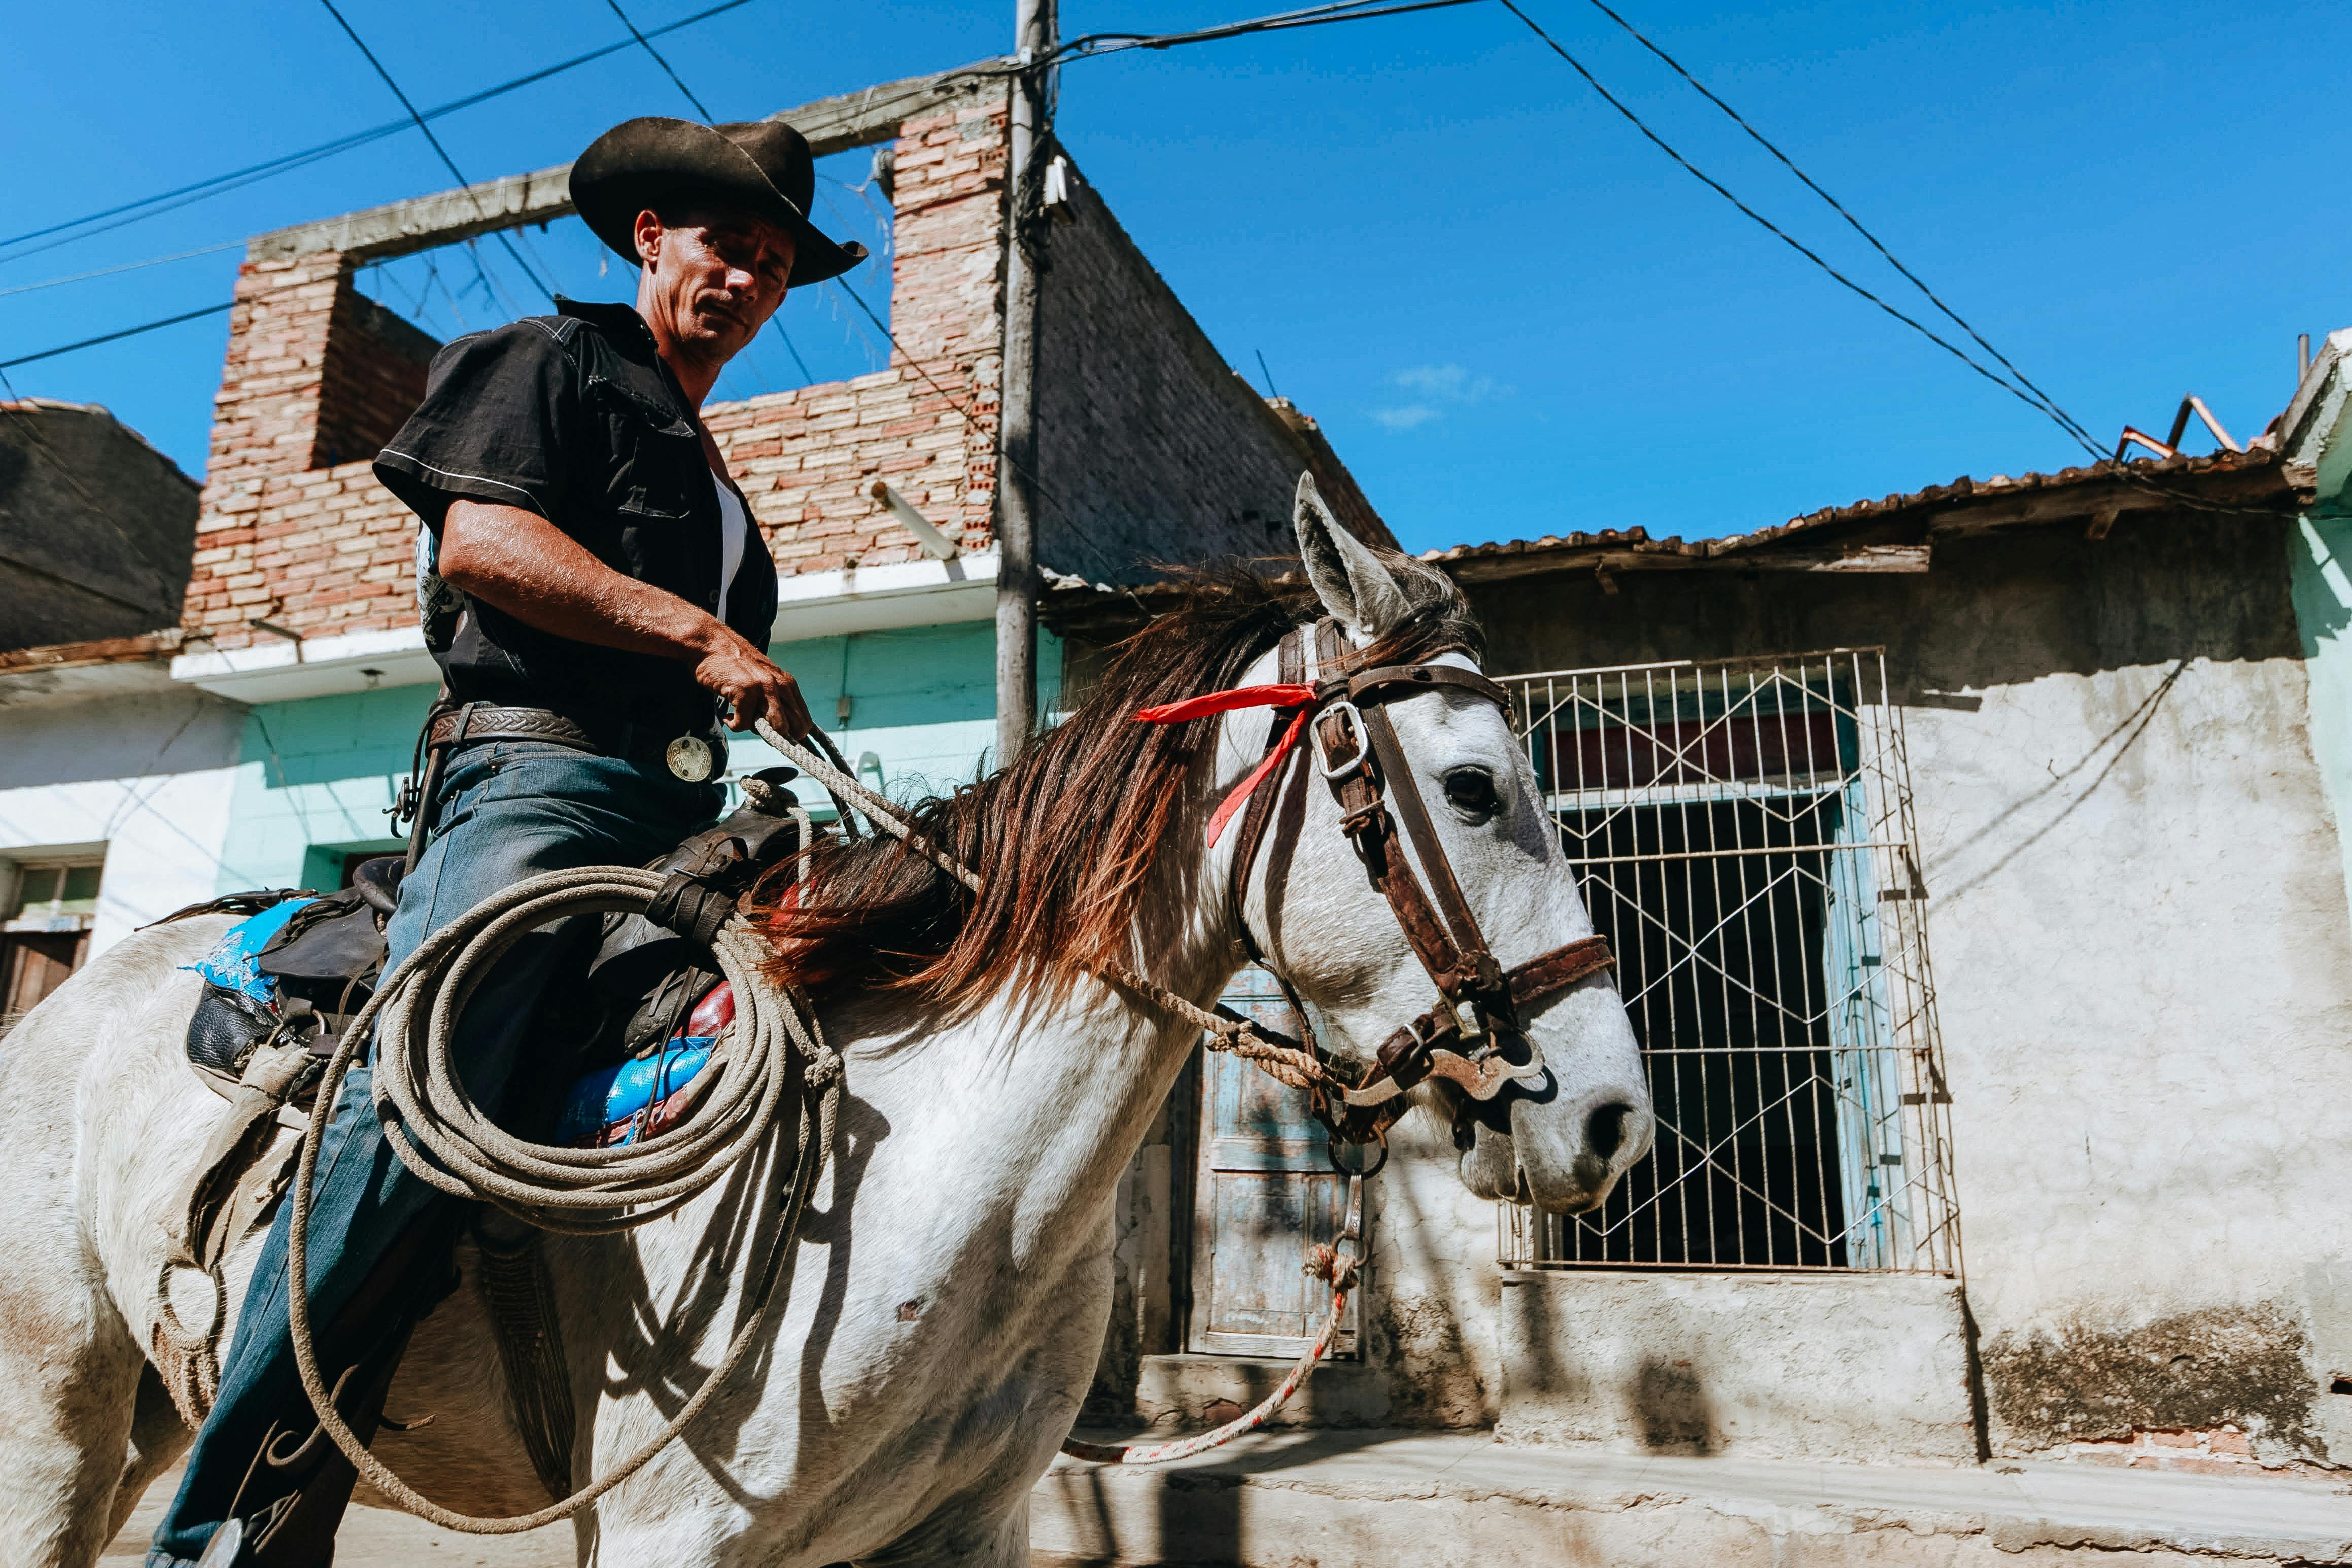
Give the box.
[997,0,1056,766]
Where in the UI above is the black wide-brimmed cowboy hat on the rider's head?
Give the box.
[572,115,866,287]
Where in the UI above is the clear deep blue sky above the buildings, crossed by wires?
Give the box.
[0,0,2352,548]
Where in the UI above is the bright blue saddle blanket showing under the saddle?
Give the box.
[186,898,734,1149]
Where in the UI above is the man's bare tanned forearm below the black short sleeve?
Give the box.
[437,501,727,660]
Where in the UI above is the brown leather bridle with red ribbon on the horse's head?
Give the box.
[1136,620,1616,1168]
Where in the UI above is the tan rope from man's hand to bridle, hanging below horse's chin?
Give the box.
[753,719,1364,1465]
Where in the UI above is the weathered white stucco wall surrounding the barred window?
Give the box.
[1289,515,2352,1462]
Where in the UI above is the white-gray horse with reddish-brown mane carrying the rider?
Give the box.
[0,508,1651,1568]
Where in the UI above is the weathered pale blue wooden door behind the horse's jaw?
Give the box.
[1190,966,1362,1356]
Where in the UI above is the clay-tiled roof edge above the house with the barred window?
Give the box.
[1421,449,2310,569]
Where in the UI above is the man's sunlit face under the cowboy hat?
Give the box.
[637,207,795,362]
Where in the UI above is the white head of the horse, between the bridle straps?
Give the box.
[1218,479,1653,1213]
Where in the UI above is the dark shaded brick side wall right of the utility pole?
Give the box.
[1037,164,1393,583]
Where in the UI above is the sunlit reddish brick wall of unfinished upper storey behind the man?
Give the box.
[184,94,1007,646]
